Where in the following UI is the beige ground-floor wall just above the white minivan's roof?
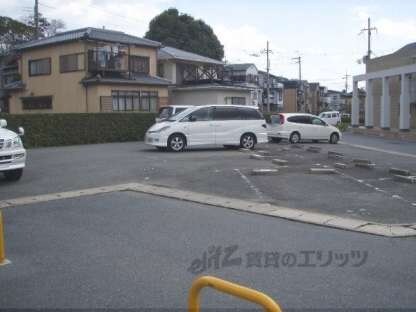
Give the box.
[170,90,250,105]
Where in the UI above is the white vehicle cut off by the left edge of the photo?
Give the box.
[0,119,26,181]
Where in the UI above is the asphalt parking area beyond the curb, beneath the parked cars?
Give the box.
[0,135,416,224]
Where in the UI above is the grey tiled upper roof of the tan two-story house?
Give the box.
[16,27,161,50]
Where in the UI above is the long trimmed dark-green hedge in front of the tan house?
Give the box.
[0,113,156,148]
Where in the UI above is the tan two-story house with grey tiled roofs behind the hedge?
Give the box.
[5,28,170,114]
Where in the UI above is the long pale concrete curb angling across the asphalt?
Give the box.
[0,183,416,237]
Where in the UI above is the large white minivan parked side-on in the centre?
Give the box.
[145,105,268,152]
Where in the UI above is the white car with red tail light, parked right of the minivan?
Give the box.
[269,113,341,144]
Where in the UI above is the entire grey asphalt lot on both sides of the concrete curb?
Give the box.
[0,135,416,311]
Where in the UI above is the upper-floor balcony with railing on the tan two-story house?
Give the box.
[88,50,128,72]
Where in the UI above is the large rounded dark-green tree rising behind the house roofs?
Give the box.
[145,8,224,60]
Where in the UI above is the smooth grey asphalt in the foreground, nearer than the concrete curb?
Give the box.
[0,193,416,311]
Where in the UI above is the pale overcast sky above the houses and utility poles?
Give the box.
[0,0,416,90]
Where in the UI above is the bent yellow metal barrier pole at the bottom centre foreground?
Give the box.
[188,276,282,312]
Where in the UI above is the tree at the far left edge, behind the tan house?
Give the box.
[0,16,35,54]
